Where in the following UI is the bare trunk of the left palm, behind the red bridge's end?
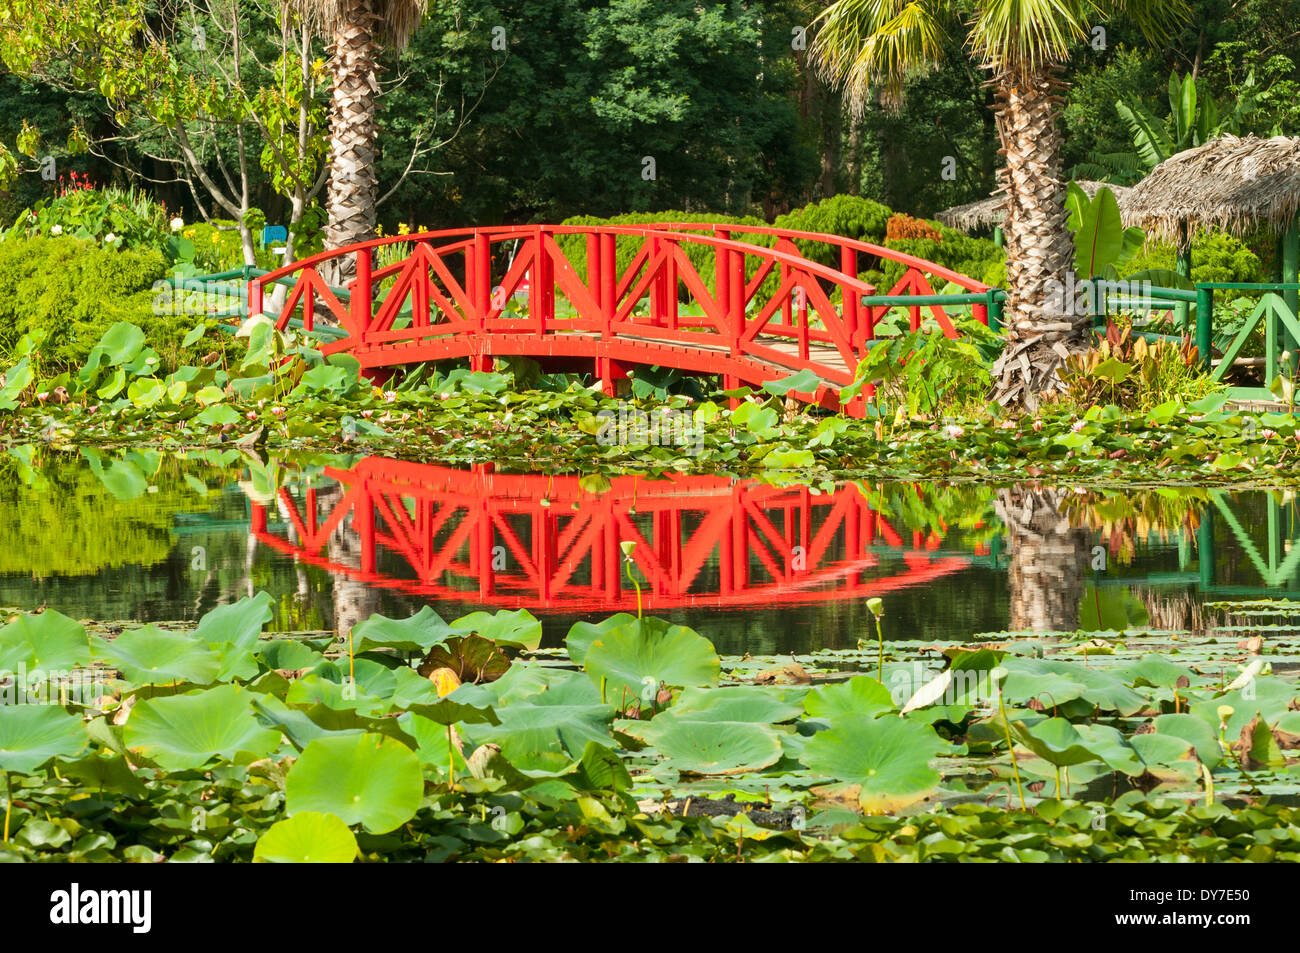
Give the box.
[325,0,380,277]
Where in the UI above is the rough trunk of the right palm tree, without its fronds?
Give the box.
[993,69,1089,411]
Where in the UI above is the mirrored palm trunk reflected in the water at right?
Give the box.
[997,488,1088,632]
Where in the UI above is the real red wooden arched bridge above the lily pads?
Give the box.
[248,222,996,415]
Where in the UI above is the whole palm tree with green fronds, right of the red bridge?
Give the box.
[810,0,1187,410]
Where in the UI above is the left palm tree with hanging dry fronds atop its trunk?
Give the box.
[286,0,426,258]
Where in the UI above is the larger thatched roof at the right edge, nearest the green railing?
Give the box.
[1117,135,1300,246]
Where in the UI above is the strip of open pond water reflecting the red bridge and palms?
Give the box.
[0,449,1300,655]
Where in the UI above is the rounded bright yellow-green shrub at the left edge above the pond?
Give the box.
[0,235,224,373]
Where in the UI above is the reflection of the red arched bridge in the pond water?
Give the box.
[245,456,987,612]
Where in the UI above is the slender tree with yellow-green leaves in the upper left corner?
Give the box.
[0,0,325,265]
